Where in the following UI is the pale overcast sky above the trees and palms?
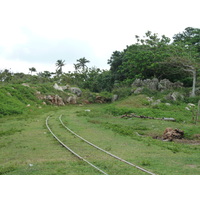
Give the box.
[0,0,200,73]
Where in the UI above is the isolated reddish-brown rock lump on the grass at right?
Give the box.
[163,128,184,141]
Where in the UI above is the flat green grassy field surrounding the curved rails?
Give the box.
[0,96,200,175]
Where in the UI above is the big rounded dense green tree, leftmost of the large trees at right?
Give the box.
[108,31,170,83]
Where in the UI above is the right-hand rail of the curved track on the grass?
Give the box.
[59,115,156,175]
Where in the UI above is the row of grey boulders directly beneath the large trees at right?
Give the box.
[132,78,183,94]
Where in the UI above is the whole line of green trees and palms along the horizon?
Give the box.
[0,27,200,96]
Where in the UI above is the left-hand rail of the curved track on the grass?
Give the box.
[46,116,108,175]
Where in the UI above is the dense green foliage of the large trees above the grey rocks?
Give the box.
[108,28,200,86]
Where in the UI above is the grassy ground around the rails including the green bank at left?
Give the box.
[0,83,200,174]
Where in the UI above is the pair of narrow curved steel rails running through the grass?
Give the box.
[46,115,156,175]
